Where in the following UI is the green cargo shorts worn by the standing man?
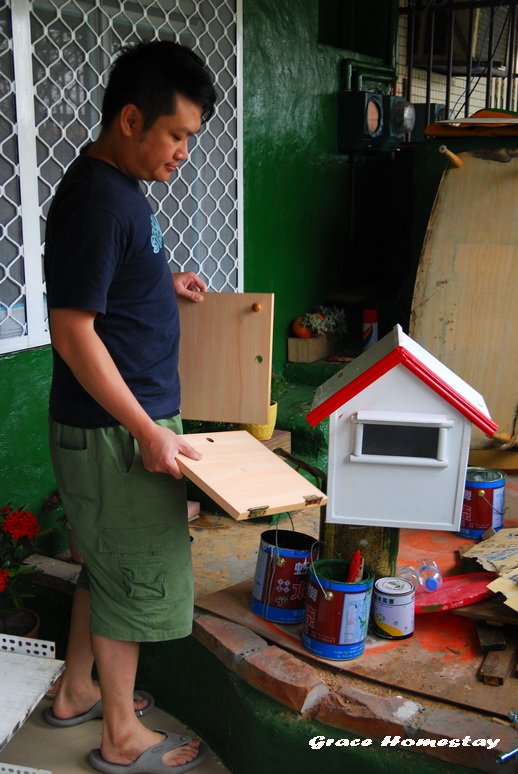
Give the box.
[49,416,194,642]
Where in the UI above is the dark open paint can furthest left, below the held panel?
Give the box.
[251,529,319,623]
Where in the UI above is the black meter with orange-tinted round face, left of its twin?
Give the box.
[338,91,383,153]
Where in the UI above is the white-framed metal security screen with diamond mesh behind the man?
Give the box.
[0,0,241,352]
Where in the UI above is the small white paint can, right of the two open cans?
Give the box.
[372,578,415,640]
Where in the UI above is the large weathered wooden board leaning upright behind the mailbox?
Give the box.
[410,151,518,445]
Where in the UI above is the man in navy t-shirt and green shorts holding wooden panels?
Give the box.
[45,41,215,773]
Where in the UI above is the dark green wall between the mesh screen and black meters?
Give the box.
[243,0,348,366]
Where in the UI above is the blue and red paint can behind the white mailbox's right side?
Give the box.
[459,468,506,539]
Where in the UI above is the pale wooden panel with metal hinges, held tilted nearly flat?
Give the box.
[177,430,326,519]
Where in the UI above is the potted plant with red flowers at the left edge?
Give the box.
[0,503,44,636]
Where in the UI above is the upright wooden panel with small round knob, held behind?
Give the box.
[178,293,274,423]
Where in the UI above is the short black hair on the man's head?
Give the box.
[102,40,216,130]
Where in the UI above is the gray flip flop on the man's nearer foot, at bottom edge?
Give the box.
[88,728,207,774]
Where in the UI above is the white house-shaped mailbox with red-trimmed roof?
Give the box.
[307,325,498,530]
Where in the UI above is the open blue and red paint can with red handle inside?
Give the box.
[302,559,374,660]
